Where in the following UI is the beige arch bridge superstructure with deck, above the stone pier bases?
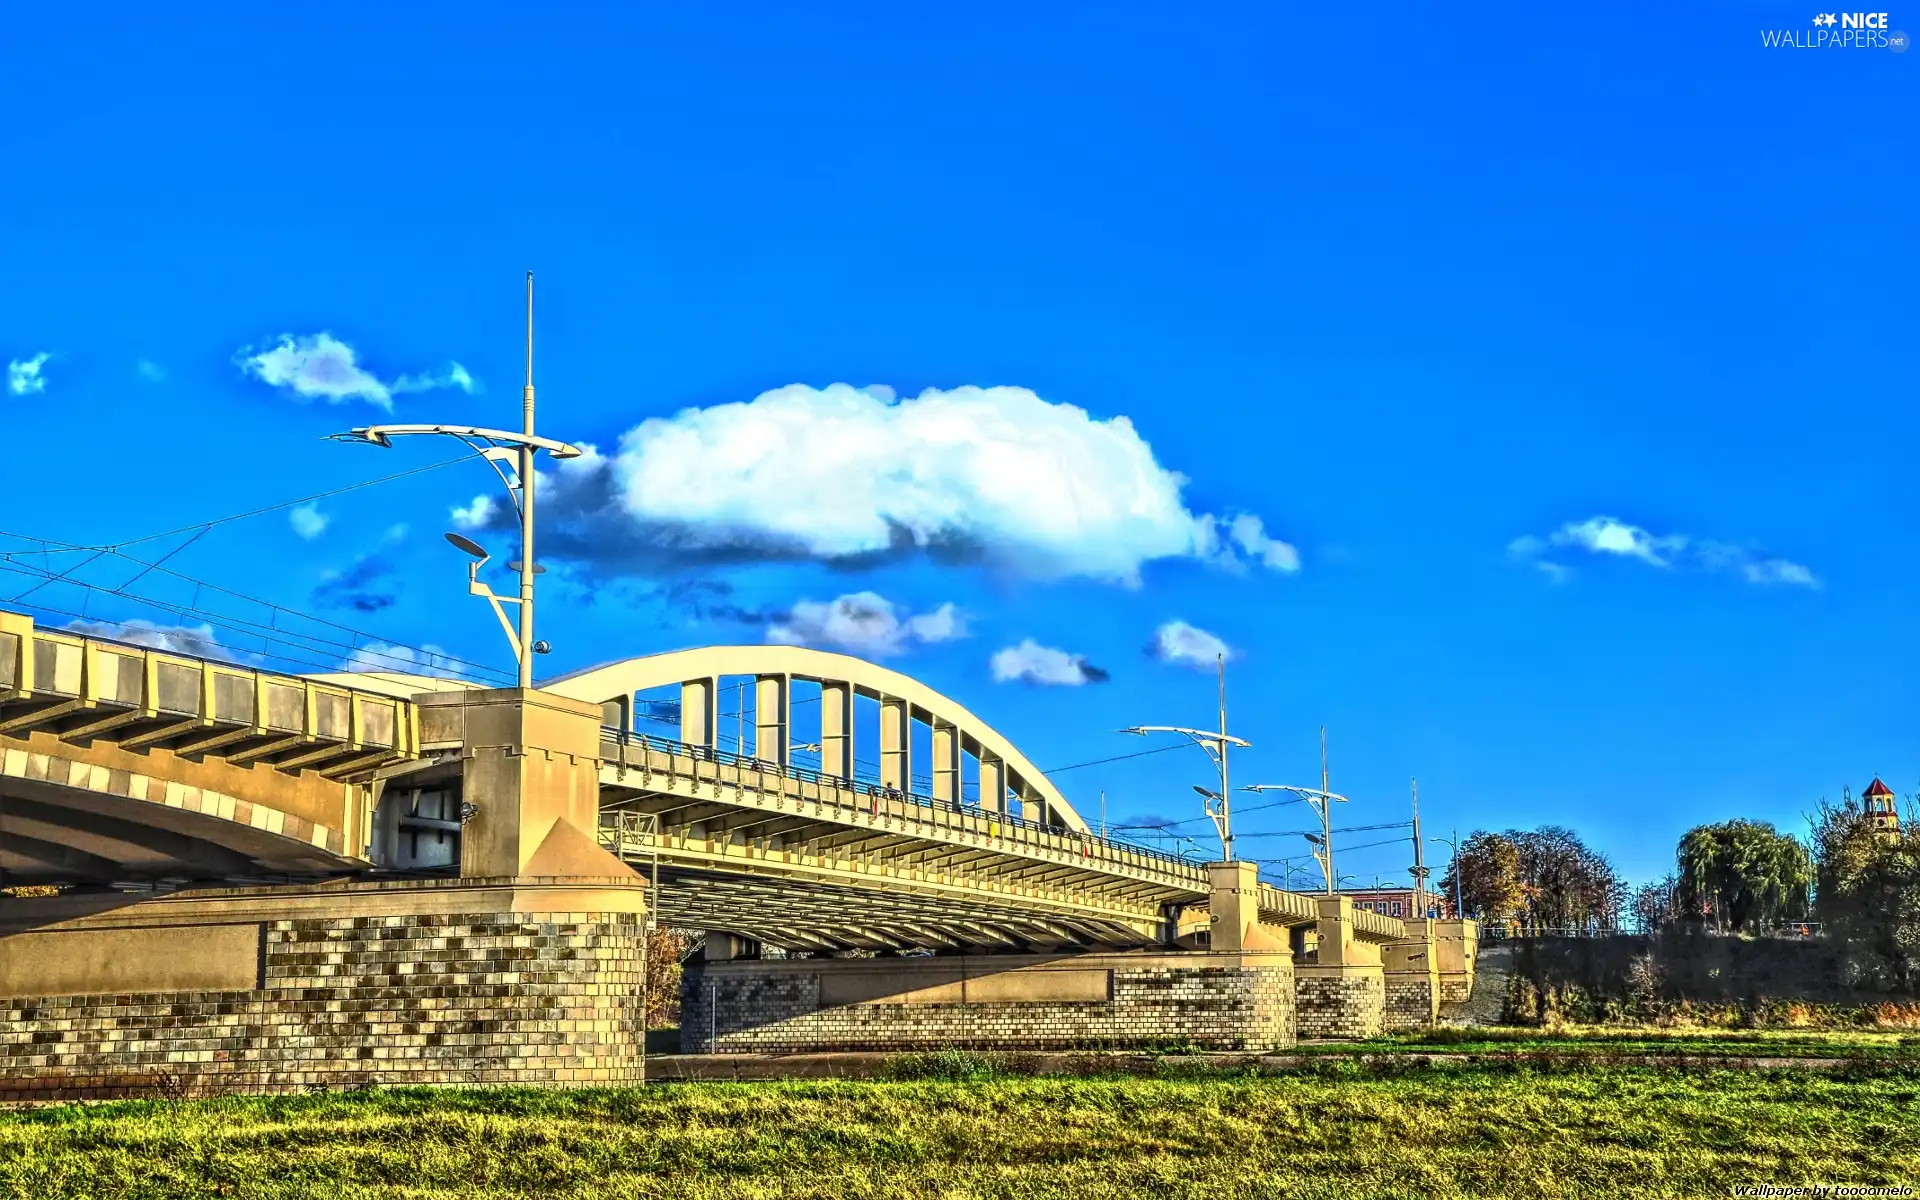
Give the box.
[0,612,1405,952]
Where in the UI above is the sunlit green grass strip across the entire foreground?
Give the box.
[0,1064,1920,1200]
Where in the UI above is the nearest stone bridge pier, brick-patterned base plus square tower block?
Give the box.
[0,675,647,1100]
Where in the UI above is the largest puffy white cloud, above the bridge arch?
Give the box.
[457,384,1300,586]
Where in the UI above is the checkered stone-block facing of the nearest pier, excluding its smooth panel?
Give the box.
[0,871,645,1100]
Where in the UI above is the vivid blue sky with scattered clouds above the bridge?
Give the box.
[0,4,1920,879]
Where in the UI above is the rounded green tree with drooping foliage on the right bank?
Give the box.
[1676,820,1812,933]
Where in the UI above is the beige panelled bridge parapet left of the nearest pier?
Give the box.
[0,612,420,781]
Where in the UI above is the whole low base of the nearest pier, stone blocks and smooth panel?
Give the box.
[0,877,645,1100]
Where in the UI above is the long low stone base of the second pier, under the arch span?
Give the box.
[680,954,1294,1054]
